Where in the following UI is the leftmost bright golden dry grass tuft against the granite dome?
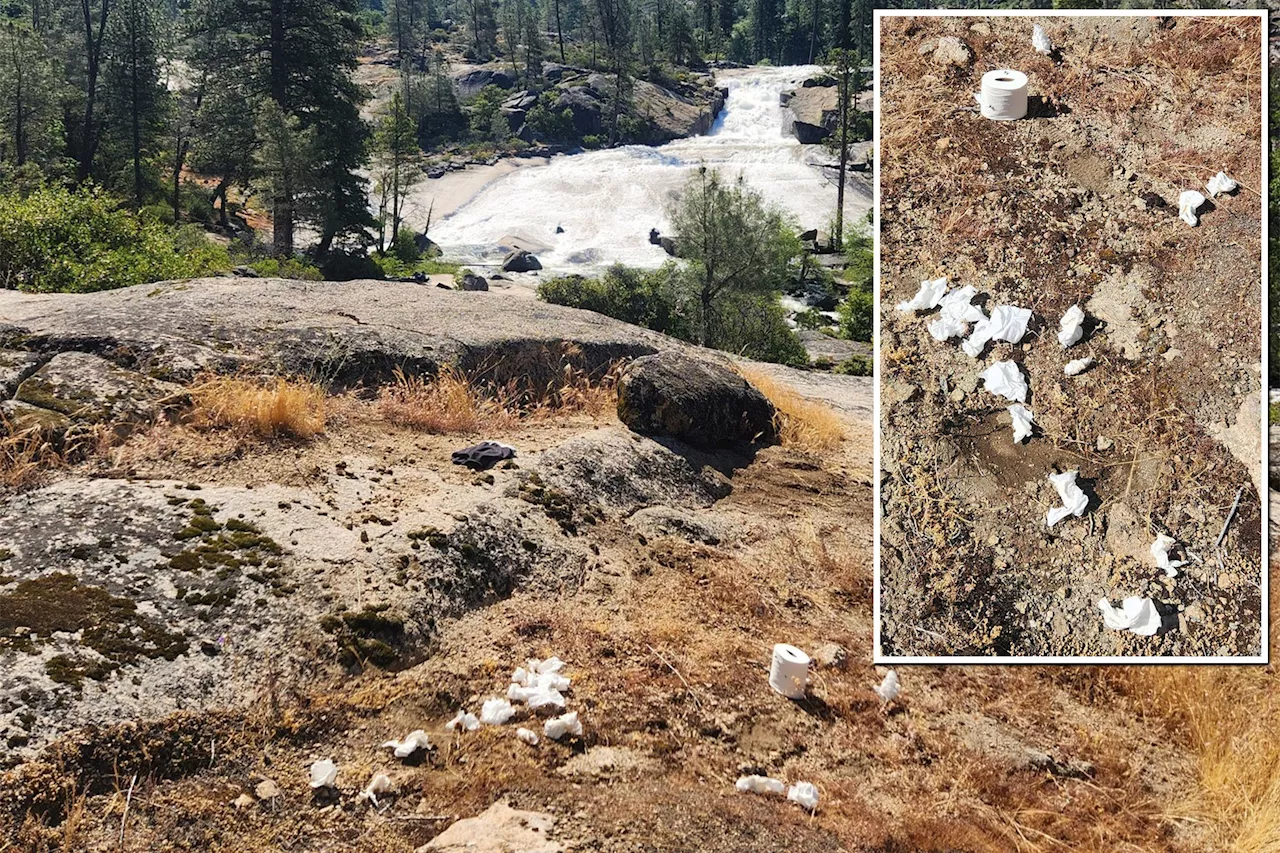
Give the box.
[191,377,328,438]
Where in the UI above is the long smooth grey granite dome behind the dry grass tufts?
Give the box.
[0,278,691,387]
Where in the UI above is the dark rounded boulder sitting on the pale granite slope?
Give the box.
[618,352,777,447]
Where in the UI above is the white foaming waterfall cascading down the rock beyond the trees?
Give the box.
[419,67,870,269]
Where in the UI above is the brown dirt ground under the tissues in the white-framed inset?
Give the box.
[878,17,1266,656]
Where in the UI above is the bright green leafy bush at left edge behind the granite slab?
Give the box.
[0,180,230,293]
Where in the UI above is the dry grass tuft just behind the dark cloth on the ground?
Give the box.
[378,368,516,434]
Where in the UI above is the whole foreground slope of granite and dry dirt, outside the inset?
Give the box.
[0,279,1233,852]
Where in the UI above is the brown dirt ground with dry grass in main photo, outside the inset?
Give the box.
[0,381,1249,853]
